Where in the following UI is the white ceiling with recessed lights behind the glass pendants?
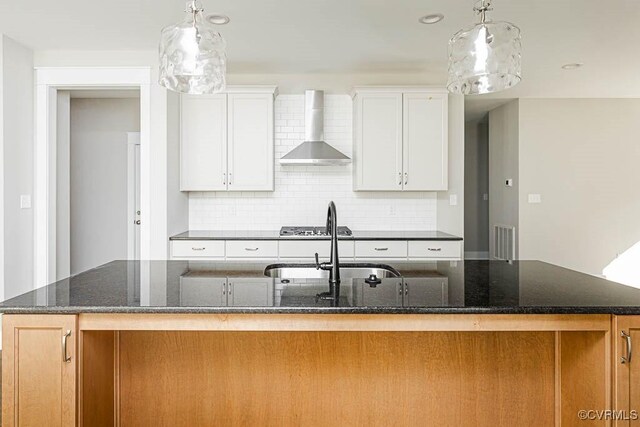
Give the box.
[0,0,640,115]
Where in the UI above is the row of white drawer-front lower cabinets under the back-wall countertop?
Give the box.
[171,239,462,262]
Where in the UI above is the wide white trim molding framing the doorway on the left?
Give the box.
[34,67,152,288]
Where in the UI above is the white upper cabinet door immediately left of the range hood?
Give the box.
[228,94,274,191]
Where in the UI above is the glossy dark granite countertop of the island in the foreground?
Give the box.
[0,261,640,314]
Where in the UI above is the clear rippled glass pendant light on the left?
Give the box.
[159,0,227,95]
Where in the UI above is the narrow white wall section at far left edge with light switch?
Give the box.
[0,35,34,298]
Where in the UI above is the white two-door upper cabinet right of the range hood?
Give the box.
[353,87,448,191]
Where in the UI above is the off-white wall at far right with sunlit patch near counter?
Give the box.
[519,99,640,276]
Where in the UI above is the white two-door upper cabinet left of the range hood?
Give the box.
[180,86,276,191]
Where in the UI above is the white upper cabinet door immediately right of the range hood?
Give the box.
[354,93,402,191]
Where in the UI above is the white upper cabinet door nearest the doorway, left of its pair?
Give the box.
[180,95,227,191]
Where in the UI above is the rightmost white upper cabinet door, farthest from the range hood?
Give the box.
[402,93,448,191]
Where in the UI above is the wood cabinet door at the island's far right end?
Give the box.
[613,316,640,426]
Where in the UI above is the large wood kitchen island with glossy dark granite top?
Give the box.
[0,261,640,426]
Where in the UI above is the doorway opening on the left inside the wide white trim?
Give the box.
[52,89,141,280]
